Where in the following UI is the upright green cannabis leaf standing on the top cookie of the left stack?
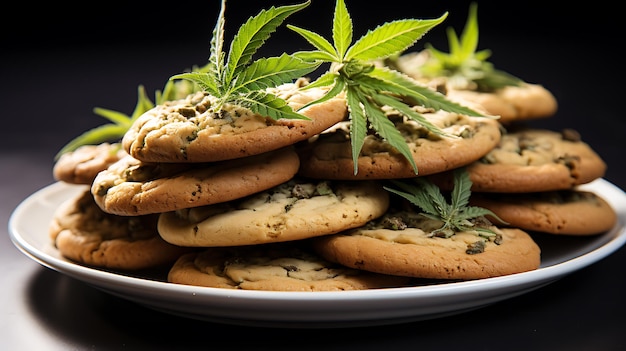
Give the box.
[170,0,321,119]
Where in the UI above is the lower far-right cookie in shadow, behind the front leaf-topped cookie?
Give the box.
[470,190,617,235]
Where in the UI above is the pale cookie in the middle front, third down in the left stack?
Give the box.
[158,178,389,247]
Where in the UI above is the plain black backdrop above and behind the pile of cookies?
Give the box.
[0,0,625,186]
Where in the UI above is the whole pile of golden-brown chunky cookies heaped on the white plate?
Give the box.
[51,69,615,291]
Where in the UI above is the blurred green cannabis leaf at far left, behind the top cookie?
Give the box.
[54,85,154,160]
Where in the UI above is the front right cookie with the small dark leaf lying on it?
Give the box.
[311,212,541,280]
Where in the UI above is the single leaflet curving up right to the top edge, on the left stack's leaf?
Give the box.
[224,0,311,85]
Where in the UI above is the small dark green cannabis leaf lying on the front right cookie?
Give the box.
[384,167,506,238]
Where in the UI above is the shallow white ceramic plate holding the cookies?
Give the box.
[9,179,626,328]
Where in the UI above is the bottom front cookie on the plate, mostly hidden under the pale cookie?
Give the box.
[168,243,410,291]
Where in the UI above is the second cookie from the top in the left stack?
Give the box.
[91,146,299,216]
